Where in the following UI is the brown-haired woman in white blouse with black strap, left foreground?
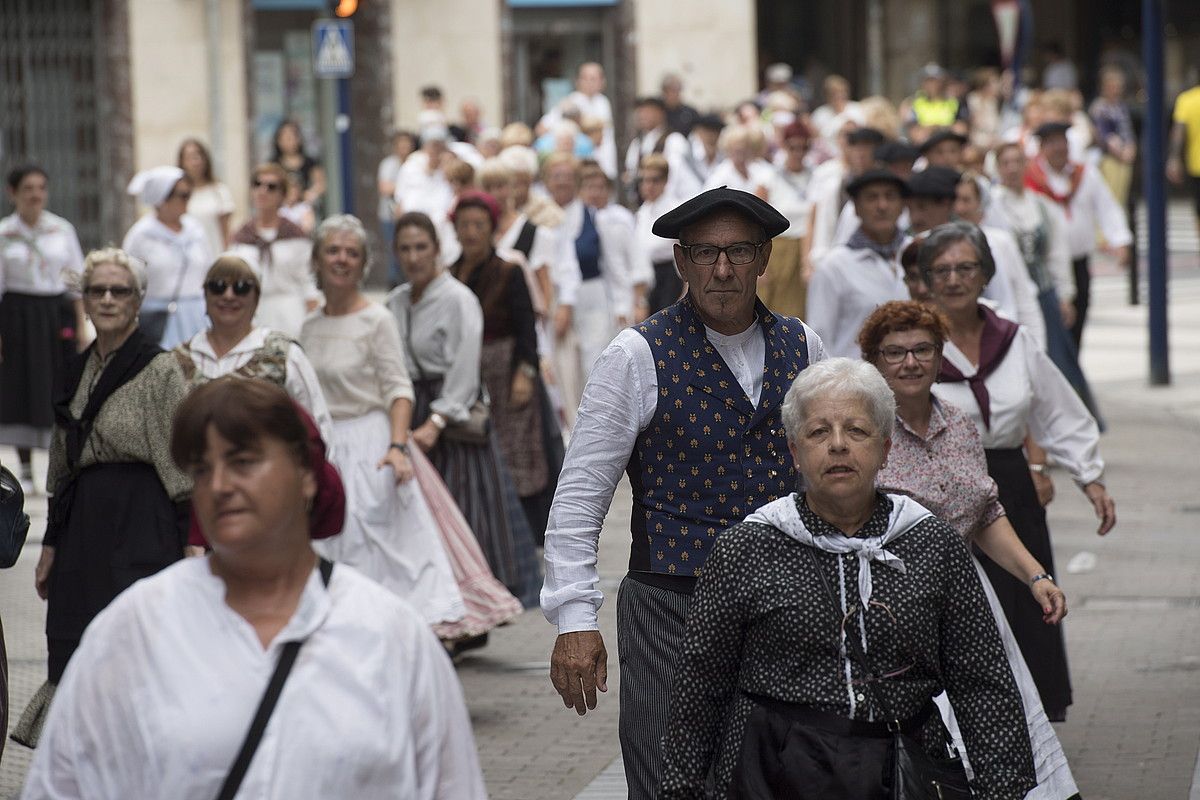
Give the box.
[22,377,486,800]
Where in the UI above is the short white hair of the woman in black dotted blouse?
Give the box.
[782,359,896,441]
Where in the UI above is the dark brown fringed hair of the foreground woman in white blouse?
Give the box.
[170,375,312,471]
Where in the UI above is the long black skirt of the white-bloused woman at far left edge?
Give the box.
[0,291,76,449]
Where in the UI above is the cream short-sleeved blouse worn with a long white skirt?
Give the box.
[300,302,413,420]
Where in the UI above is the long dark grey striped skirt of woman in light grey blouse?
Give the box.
[413,378,541,608]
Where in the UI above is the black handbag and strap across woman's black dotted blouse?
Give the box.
[809,548,973,800]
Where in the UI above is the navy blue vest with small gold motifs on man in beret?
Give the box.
[625,297,809,577]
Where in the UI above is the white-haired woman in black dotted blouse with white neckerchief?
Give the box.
[659,359,1036,800]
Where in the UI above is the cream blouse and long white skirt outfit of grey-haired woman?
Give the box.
[300,303,466,625]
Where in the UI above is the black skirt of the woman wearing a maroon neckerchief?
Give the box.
[976,449,1072,721]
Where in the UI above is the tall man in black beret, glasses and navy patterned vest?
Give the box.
[541,187,824,799]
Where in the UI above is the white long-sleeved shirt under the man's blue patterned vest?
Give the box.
[541,323,824,633]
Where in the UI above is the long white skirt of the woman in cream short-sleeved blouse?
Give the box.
[313,410,466,625]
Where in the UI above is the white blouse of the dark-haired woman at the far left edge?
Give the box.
[0,211,83,297]
